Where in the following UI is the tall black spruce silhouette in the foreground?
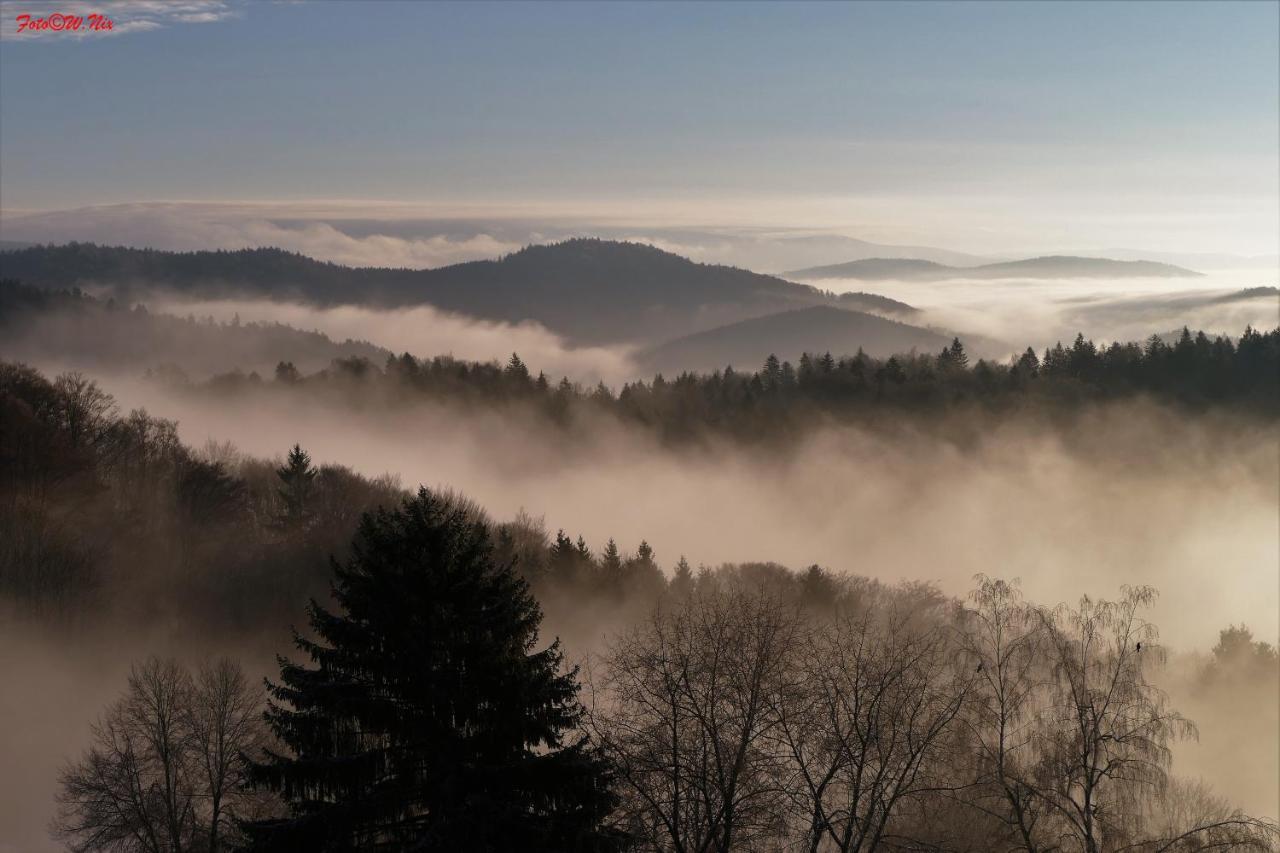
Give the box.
[247,489,614,850]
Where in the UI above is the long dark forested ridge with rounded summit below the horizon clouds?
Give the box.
[0,240,833,343]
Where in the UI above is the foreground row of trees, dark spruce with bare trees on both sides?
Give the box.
[49,481,1280,853]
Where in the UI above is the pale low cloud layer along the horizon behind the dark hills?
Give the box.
[0,201,1280,274]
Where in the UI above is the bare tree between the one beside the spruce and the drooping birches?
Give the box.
[778,612,973,853]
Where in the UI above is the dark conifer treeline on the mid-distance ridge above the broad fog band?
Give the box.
[167,322,1280,441]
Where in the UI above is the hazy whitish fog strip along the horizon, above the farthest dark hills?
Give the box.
[0,196,1277,274]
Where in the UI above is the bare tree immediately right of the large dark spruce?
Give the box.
[590,590,797,853]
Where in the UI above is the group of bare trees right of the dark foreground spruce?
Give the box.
[590,574,1277,852]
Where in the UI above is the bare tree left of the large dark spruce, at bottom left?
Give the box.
[52,658,261,853]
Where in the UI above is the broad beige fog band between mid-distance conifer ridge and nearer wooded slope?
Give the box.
[87,368,1280,649]
